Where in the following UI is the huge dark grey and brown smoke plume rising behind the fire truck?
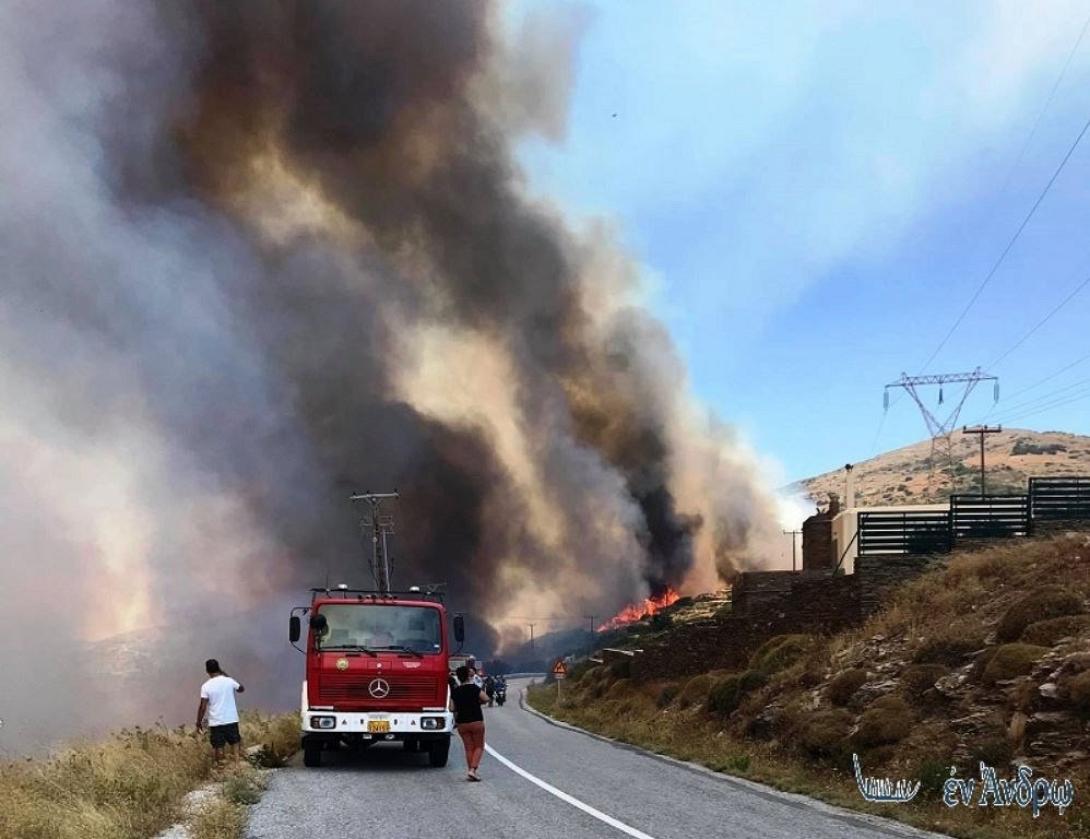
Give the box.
[0,0,776,745]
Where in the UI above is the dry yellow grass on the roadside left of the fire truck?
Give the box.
[0,714,299,839]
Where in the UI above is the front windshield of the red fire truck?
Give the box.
[317,604,441,653]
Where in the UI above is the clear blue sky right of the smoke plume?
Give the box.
[509,0,1090,477]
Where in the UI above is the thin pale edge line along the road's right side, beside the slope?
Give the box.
[519,688,953,839]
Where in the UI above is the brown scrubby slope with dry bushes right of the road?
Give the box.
[532,534,1090,839]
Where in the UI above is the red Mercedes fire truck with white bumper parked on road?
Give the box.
[289,586,465,766]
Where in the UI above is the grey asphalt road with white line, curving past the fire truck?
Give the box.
[247,681,933,839]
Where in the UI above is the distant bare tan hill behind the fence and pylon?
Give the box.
[794,428,1090,507]
